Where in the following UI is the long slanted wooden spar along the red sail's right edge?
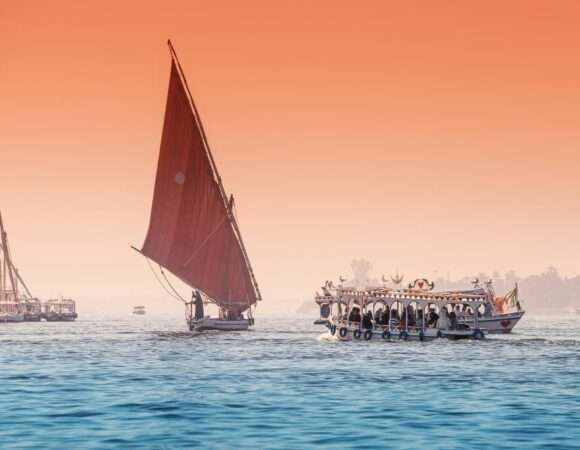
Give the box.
[167,39,262,300]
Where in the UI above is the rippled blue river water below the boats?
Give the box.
[0,317,580,450]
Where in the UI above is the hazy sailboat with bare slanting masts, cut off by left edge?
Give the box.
[0,213,40,322]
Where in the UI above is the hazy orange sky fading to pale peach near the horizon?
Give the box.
[0,0,580,314]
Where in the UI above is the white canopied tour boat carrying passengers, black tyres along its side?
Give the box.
[316,279,523,341]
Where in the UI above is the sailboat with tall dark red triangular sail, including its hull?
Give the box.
[133,41,261,331]
